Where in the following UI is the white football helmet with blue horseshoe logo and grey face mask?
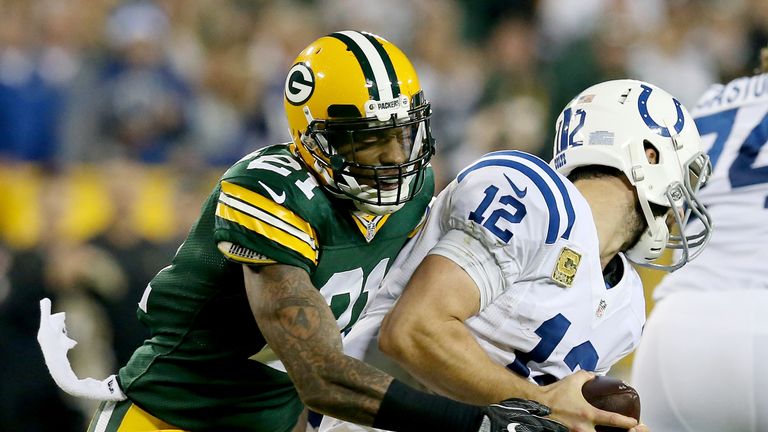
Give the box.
[551,80,712,271]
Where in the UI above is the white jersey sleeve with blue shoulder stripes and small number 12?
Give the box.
[430,152,575,310]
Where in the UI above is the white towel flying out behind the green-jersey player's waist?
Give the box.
[37,298,126,401]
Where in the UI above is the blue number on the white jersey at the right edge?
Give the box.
[696,108,768,189]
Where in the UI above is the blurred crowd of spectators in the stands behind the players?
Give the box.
[0,0,768,431]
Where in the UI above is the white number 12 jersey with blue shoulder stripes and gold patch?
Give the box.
[322,151,645,431]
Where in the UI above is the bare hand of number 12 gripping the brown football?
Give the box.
[540,371,648,432]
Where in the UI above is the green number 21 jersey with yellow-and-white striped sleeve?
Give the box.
[119,145,434,431]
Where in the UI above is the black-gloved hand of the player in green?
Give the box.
[478,399,568,432]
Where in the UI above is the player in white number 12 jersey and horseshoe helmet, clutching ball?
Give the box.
[321,80,711,432]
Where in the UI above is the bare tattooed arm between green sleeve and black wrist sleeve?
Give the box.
[243,264,392,425]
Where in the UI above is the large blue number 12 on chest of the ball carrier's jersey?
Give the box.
[507,314,600,384]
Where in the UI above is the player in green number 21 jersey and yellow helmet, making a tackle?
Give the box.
[39,31,564,432]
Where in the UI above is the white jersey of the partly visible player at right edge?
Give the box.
[654,74,768,299]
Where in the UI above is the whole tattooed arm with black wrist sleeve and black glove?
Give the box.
[243,264,566,432]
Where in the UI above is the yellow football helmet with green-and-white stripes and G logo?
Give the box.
[285,31,434,215]
